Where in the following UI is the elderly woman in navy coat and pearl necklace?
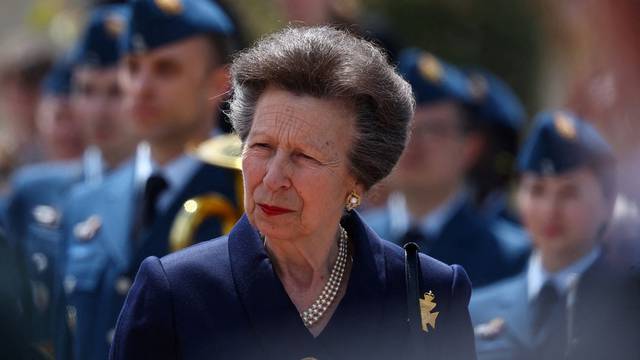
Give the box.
[111,27,475,359]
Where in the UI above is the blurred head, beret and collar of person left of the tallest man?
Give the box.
[71,5,138,182]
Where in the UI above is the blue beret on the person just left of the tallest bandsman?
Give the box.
[74,5,130,68]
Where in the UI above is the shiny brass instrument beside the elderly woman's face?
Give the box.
[169,134,244,252]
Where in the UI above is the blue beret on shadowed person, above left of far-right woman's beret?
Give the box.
[469,71,527,132]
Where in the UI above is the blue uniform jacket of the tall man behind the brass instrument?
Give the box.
[56,162,236,360]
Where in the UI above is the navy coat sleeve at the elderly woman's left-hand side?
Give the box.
[109,256,178,360]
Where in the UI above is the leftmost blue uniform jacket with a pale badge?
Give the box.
[6,161,83,348]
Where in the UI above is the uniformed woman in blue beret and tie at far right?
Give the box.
[470,111,640,360]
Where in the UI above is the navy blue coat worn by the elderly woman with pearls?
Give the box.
[110,213,475,360]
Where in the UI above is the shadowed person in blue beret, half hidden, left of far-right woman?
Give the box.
[467,69,531,276]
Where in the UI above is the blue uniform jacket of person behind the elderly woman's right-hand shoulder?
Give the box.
[365,201,528,287]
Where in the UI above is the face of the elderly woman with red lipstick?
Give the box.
[242,87,362,241]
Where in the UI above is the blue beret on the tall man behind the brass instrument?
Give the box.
[123,0,235,54]
